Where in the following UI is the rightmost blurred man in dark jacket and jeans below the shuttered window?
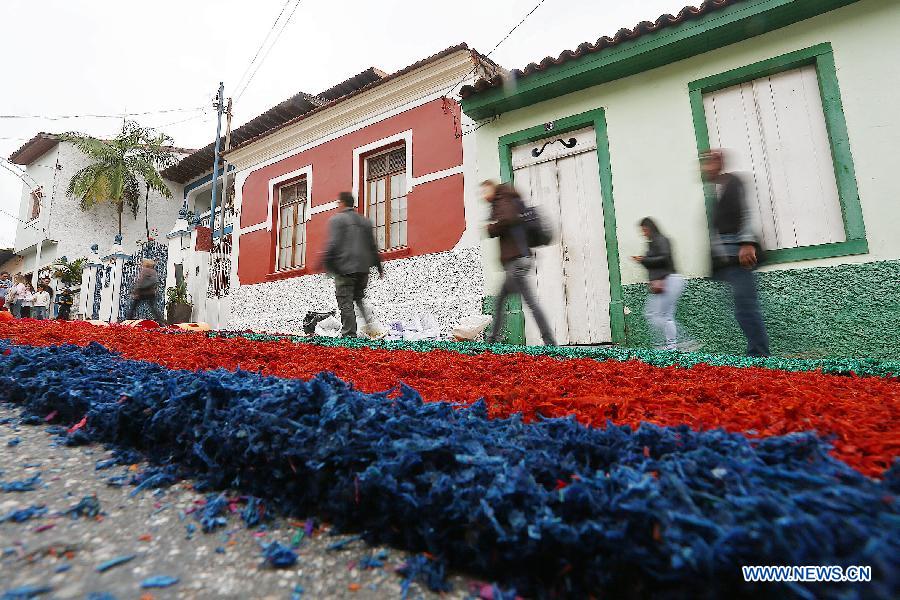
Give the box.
[700,150,769,356]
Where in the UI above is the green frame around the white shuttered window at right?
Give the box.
[688,43,869,263]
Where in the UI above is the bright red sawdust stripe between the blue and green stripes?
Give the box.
[0,320,900,476]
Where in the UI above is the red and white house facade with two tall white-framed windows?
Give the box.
[227,45,491,331]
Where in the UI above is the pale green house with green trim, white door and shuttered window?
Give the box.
[462,0,900,358]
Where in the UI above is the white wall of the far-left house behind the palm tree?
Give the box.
[15,142,183,271]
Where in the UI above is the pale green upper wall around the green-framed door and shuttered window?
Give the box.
[466,0,900,291]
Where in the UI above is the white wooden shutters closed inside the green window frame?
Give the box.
[703,65,846,250]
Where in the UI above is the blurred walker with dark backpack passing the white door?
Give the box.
[481,180,556,346]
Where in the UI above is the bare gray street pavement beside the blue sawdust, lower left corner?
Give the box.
[0,405,477,600]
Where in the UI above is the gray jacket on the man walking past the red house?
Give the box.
[325,208,381,275]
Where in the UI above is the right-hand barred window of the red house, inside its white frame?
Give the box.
[364,146,407,250]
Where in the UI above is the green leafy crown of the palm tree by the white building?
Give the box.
[62,121,176,237]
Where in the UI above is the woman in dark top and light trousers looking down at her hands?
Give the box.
[633,217,696,350]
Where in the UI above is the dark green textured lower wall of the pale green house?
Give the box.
[625,261,900,358]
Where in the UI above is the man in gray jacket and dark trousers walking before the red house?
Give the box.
[325,192,384,337]
